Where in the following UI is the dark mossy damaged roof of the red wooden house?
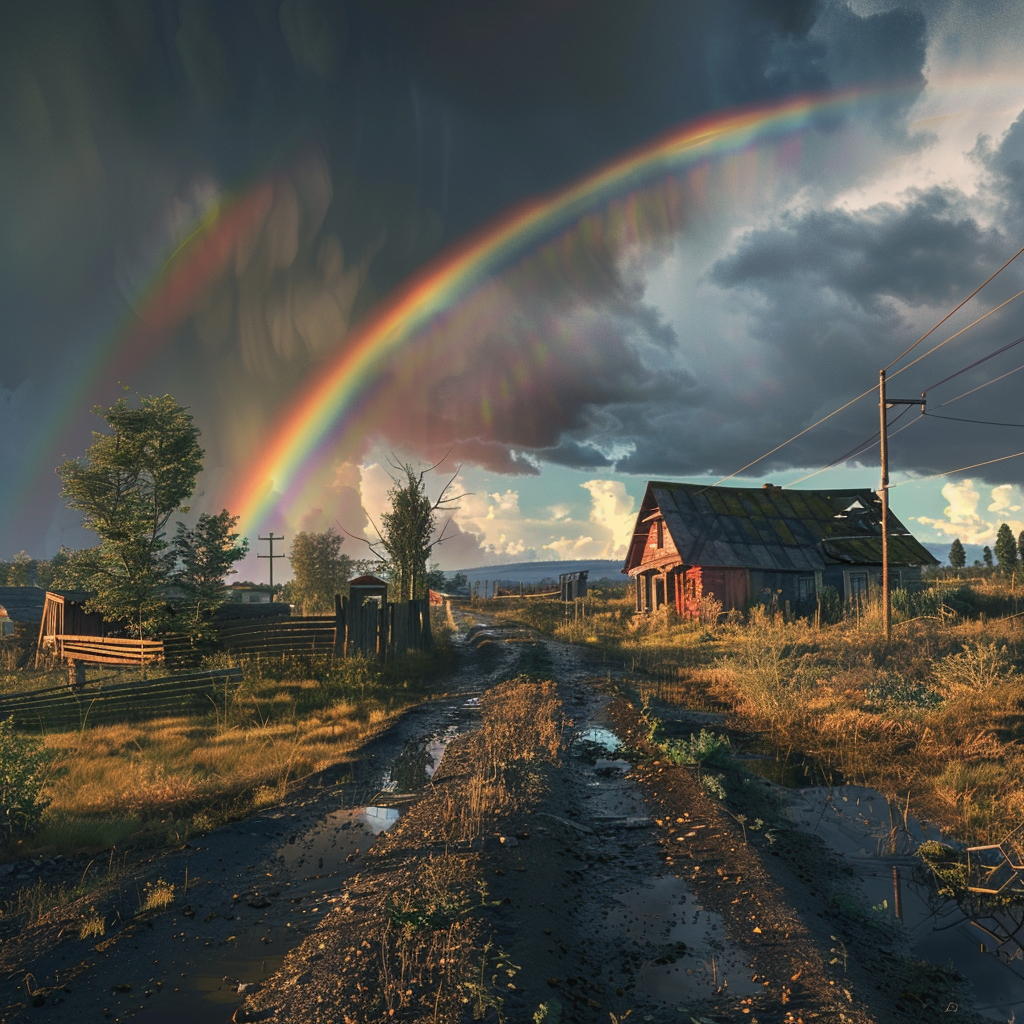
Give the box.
[626,480,938,572]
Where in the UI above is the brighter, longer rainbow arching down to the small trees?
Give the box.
[225,85,915,531]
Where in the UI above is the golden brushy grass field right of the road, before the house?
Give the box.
[487,577,1024,843]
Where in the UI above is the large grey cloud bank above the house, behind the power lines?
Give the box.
[602,121,1022,480]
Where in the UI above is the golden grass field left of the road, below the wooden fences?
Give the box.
[0,629,453,859]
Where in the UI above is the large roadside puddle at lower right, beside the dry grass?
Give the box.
[786,785,1024,1021]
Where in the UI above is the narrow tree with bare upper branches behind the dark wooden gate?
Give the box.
[371,464,458,601]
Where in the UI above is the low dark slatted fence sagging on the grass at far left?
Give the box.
[0,669,242,732]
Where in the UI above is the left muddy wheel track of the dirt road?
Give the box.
[0,625,532,1024]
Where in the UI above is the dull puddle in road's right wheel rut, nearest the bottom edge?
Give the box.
[602,876,761,1005]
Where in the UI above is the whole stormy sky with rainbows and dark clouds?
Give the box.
[6,0,1024,579]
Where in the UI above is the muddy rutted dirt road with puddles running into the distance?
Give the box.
[0,614,991,1024]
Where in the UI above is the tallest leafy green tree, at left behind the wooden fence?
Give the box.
[57,395,204,632]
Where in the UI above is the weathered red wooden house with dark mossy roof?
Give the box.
[623,481,938,617]
